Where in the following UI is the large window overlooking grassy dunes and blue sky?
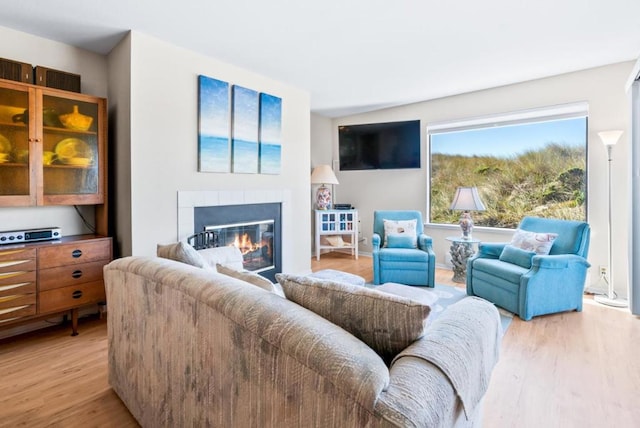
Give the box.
[428,103,587,228]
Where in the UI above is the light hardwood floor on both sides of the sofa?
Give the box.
[0,253,640,428]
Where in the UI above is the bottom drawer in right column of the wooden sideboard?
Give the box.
[39,281,106,314]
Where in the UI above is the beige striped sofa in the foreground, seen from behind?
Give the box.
[105,249,501,428]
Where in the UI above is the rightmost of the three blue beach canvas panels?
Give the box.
[260,94,282,174]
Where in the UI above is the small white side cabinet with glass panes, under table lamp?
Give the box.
[315,210,358,260]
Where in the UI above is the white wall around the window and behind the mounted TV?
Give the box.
[312,62,633,296]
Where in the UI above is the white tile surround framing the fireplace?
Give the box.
[178,189,293,249]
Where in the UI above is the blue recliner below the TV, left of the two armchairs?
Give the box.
[371,211,436,287]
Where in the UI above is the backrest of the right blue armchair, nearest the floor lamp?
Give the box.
[518,217,591,259]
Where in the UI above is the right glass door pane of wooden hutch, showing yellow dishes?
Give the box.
[39,94,102,203]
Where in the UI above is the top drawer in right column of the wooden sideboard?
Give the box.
[38,239,111,269]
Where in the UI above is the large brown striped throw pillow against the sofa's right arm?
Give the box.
[276,273,431,363]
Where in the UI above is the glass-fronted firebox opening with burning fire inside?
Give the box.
[205,220,275,272]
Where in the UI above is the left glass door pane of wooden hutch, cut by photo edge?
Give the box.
[0,85,35,204]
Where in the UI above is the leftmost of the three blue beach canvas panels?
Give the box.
[198,76,231,172]
